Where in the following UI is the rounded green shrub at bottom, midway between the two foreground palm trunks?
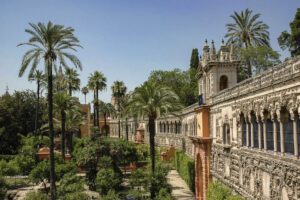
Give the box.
[96,168,122,195]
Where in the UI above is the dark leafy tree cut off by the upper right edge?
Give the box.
[278,8,300,56]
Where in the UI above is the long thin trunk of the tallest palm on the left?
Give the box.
[46,59,56,200]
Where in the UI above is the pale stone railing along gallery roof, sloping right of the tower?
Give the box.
[210,56,300,104]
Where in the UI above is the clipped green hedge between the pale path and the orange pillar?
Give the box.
[173,151,195,192]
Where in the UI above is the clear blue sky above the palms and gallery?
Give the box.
[0,0,300,102]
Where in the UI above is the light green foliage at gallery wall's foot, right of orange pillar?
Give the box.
[207,181,244,200]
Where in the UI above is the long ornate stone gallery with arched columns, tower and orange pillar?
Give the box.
[111,42,300,200]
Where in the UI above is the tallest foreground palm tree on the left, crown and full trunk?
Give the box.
[19,22,81,200]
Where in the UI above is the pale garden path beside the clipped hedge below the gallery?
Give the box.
[167,170,195,200]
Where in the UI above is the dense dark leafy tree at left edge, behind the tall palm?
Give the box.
[0,90,45,154]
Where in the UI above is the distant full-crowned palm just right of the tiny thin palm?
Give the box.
[89,71,106,128]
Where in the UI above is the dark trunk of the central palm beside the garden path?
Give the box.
[149,117,155,199]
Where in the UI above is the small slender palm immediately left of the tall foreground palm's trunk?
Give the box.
[28,70,45,136]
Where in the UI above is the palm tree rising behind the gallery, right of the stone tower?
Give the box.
[225,9,270,76]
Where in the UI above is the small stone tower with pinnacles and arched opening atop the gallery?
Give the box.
[198,40,240,105]
